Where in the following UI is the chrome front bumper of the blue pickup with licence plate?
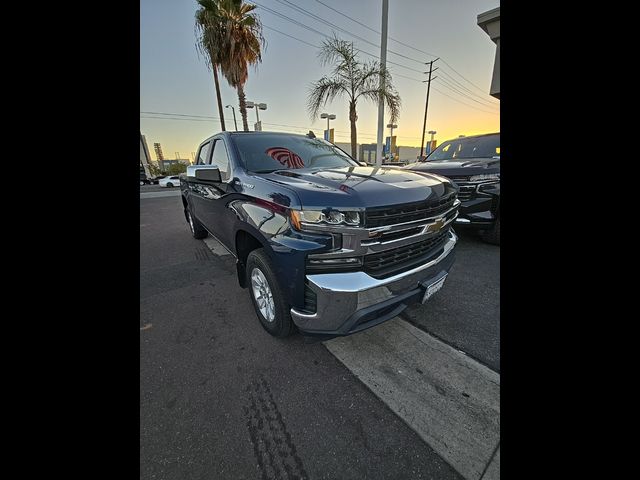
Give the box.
[291,230,458,335]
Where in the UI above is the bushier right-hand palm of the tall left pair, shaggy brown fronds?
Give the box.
[216,0,265,132]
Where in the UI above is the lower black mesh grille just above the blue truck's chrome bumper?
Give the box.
[364,226,450,278]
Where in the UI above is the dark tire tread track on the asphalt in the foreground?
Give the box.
[243,377,309,480]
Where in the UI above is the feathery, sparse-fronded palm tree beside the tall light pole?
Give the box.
[307,36,401,158]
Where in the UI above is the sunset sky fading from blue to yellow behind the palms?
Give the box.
[140,0,500,159]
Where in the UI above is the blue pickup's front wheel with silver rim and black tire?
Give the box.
[246,248,294,338]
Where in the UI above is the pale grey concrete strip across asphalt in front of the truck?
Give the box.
[325,318,500,480]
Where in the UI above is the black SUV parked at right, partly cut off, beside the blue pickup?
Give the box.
[405,133,500,245]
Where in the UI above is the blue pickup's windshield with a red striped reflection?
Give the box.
[232,134,358,173]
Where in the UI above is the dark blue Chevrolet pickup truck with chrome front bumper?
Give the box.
[180,132,460,340]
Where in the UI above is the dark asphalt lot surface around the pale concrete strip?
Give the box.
[140,193,500,479]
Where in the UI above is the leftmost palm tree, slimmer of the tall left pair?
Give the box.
[196,0,226,132]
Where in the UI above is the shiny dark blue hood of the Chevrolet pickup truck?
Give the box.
[260,167,455,209]
